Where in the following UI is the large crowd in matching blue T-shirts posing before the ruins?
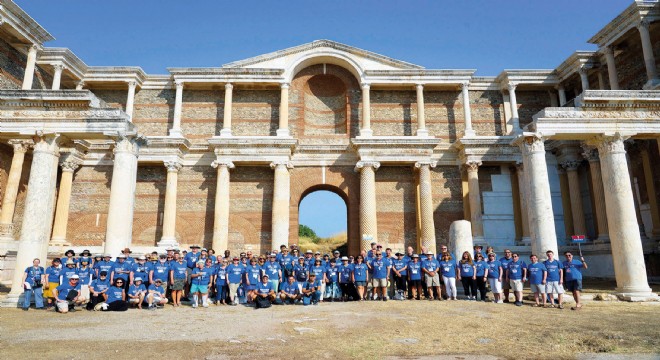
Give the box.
[23,243,587,313]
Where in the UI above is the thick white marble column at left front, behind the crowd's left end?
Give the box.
[9,135,60,299]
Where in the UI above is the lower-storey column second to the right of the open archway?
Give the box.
[415,161,436,252]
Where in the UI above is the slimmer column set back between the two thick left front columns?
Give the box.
[50,154,81,246]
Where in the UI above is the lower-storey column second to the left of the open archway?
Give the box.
[211,160,236,254]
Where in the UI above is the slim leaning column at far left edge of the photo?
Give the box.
[0,140,31,245]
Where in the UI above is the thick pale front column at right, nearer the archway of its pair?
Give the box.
[516,135,558,259]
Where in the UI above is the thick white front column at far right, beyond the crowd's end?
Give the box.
[593,133,657,301]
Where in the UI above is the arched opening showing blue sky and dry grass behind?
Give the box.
[298,188,348,255]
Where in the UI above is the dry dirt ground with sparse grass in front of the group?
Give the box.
[0,290,660,359]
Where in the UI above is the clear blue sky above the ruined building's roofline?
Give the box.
[16,0,631,75]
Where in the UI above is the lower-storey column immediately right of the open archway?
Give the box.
[355,161,380,251]
